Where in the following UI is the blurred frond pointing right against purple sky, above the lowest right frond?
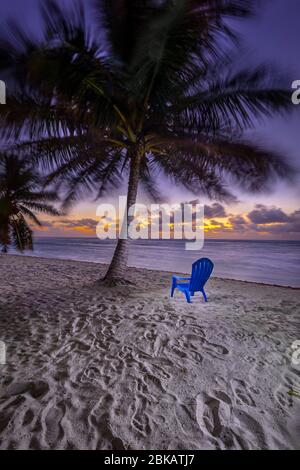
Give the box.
[172,67,291,133]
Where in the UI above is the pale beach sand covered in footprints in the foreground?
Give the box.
[0,255,300,450]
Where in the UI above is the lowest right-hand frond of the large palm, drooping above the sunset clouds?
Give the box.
[153,135,295,199]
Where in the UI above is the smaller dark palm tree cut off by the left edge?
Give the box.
[0,152,59,253]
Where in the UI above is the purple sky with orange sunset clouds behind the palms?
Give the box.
[0,0,300,240]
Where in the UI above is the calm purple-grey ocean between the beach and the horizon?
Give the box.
[7,238,300,287]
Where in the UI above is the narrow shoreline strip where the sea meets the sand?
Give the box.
[0,253,300,291]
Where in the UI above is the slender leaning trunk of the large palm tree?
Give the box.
[104,144,142,283]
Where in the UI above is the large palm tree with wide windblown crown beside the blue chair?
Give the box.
[0,0,290,281]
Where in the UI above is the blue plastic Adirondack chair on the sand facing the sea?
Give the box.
[171,258,214,304]
